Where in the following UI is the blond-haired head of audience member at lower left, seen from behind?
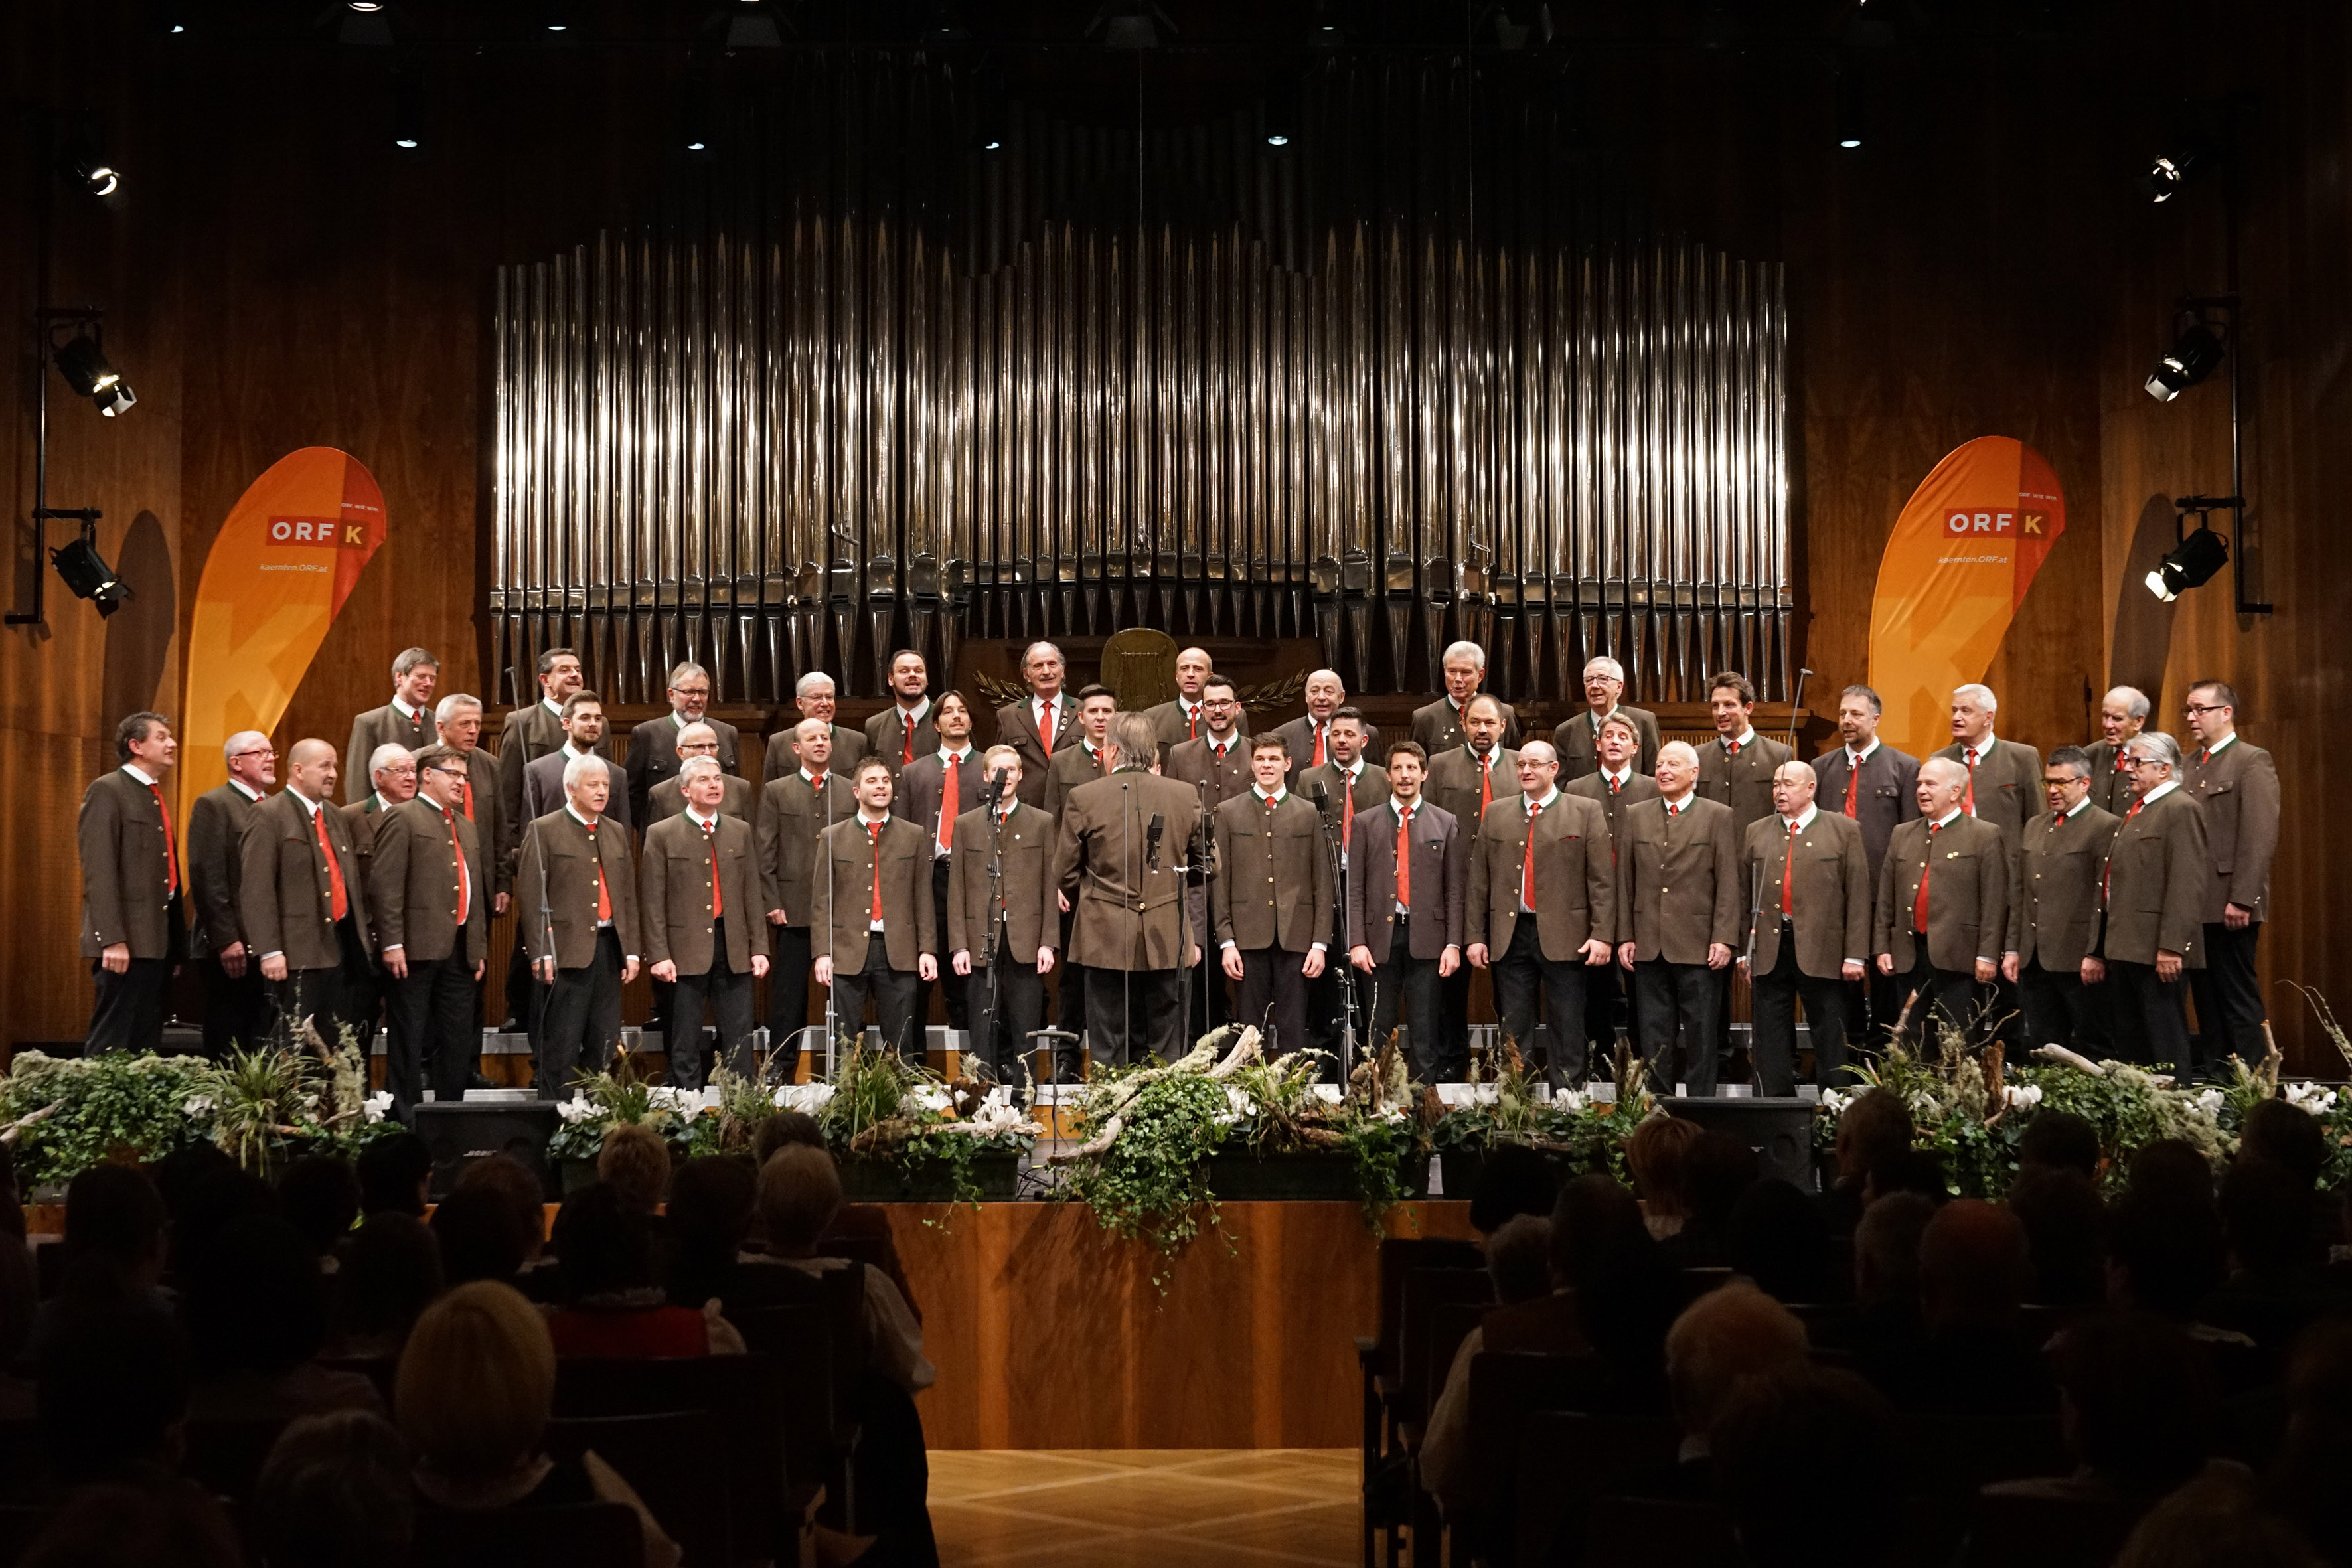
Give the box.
[393,1279,560,1481]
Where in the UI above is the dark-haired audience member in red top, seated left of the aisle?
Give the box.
[548,1182,744,1359]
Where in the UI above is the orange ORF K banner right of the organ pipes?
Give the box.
[1870,435,2065,757]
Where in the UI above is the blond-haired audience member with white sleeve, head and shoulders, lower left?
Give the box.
[393,1279,677,1568]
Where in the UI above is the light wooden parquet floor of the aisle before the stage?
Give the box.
[931,1448,1360,1568]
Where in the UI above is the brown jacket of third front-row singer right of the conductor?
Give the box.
[1463,790,1616,964]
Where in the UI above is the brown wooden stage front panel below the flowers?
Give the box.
[887,1202,1470,1448]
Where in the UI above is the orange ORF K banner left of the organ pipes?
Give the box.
[179,447,384,821]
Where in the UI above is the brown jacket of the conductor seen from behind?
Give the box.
[1058,771,1200,973]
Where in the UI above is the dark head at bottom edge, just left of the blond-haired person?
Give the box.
[250,1411,416,1568]
